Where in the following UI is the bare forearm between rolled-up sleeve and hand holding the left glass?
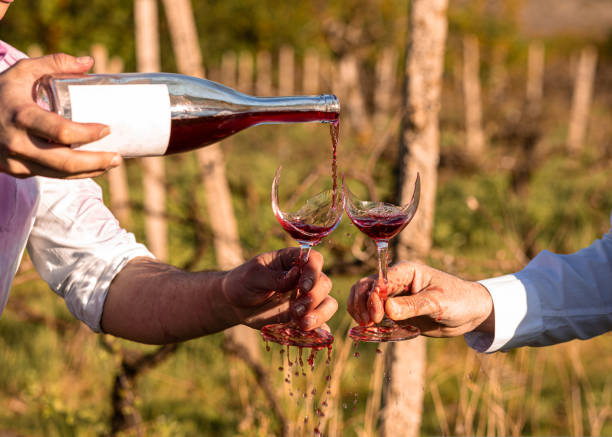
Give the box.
[101,258,238,344]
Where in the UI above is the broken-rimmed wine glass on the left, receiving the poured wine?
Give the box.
[261,167,344,348]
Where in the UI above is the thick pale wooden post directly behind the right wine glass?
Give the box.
[388,0,448,437]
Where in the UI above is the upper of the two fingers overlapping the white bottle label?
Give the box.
[13,103,110,145]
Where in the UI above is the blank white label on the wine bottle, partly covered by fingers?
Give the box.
[68,84,171,158]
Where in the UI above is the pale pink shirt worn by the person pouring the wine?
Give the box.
[0,41,153,332]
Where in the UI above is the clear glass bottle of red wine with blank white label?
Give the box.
[34,73,340,157]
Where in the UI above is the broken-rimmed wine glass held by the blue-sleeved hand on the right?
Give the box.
[342,174,421,343]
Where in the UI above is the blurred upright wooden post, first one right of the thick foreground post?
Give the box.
[463,35,485,161]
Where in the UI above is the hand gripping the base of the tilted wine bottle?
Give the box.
[0,54,121,178]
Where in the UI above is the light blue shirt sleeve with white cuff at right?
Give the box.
[465,213,612,352]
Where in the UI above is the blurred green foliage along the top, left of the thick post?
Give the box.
[0,0,407,71]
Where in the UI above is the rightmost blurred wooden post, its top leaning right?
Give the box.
[567,46,597,154]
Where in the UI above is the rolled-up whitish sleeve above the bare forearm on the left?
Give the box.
[27,177,153,332]
